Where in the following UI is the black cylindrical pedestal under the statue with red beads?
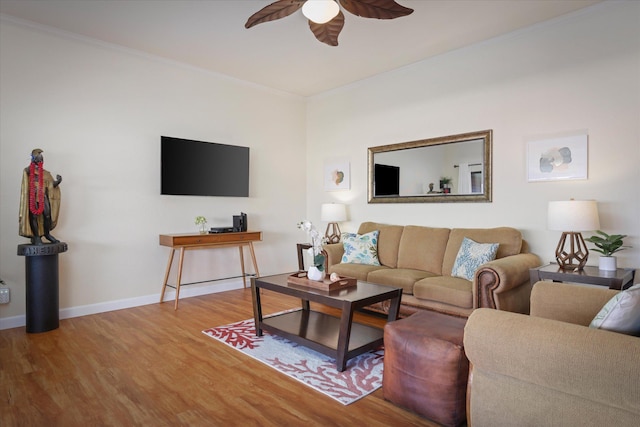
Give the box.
[18,242,67,333]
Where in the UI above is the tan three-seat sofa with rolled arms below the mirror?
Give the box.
[325,222,541,317]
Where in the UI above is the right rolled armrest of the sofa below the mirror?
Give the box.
[473,253,542,312]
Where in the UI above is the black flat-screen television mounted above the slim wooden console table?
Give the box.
[160,136,249,197]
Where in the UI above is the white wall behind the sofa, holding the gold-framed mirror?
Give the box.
[307,2,640,267]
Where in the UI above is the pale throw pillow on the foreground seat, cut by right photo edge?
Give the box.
[589,284,640,337]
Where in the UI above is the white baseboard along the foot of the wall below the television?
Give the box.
[0,279,243,330]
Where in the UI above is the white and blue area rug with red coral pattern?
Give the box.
[202,319,384,405]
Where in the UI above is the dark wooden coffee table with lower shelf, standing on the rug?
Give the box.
[251,274,402,372]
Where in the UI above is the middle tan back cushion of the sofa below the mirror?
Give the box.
[398,225,450,275]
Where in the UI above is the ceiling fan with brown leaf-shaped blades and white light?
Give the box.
[244,0,413,46]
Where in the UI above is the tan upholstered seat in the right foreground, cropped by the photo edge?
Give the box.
[464,280,640,427]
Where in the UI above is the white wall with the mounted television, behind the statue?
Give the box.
[0,19,306,329]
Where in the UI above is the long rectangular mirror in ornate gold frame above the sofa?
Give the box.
[368,129,493,203]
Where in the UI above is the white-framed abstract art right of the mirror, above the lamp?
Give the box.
[527,133,588,182]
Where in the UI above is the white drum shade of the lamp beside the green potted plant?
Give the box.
[547,200,600,231]
